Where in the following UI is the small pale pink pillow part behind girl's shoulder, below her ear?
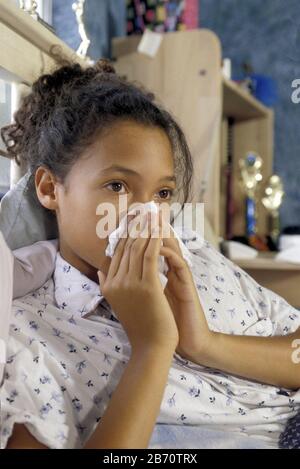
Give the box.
[13,240,58,298]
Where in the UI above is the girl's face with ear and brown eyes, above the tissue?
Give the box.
[36,121,176,282]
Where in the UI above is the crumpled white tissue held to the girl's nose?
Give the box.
[105,201,192,287]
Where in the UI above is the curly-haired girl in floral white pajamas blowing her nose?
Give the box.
[0,61,300,448]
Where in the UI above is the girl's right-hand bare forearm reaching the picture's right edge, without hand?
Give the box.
[191,329,300,390]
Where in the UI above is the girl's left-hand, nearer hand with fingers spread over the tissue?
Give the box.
[98,210,179,352]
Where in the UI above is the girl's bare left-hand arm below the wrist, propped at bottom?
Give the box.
[7,346,175,449]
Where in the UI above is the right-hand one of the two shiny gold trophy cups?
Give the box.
[262,174,284,248]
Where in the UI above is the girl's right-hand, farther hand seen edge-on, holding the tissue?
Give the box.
[160,221,214,364]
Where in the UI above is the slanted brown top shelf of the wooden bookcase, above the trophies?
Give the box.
[222,78,270,121]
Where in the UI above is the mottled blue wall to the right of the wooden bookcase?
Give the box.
[200,0,300,227]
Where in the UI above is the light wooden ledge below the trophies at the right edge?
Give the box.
[231,253,300,272]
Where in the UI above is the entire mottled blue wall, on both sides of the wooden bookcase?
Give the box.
[53,0,300,227]
